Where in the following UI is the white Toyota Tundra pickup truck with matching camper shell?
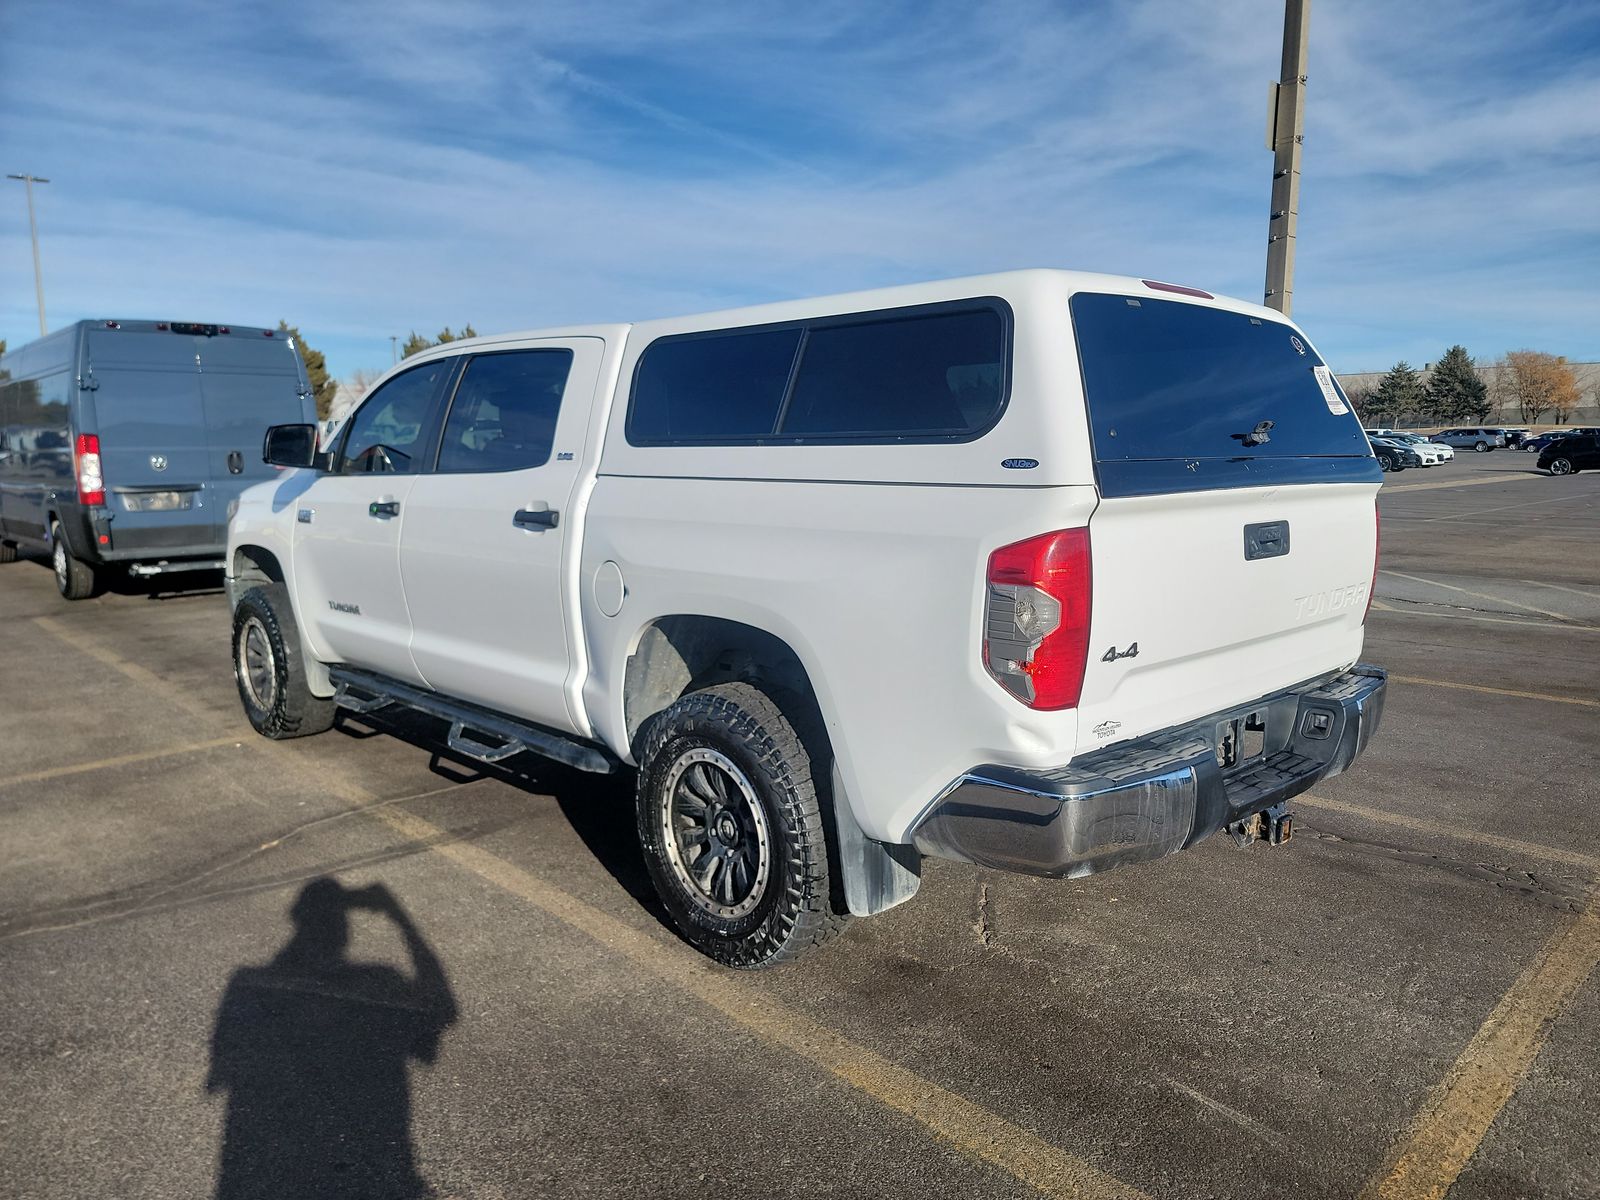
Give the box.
[227,270,1384,966]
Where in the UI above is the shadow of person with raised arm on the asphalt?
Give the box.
[206,877,458,1200]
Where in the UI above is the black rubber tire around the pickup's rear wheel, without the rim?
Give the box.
[637,683,848,970]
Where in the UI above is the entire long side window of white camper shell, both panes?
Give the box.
[627,301,1010,445]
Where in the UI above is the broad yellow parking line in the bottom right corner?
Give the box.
[1360,888,1600,1200]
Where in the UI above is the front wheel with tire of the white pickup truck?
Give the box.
[234,584,338,741]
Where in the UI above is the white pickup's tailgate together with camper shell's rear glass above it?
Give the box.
[1070,293,1381,750]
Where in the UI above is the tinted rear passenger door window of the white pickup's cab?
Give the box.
[438,350,573,470]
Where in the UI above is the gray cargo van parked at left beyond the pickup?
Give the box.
[0,320,317,600]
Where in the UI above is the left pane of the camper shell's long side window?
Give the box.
[627,326,800,445]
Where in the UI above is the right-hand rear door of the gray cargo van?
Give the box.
[195,328,317,542]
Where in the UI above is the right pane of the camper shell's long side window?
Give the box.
[778,309,1005,438]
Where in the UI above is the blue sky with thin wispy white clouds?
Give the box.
[0,0,1600,376]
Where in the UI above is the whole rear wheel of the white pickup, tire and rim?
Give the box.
[638,683,845,970]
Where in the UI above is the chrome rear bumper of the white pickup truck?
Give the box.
[910,664,1387,878]
